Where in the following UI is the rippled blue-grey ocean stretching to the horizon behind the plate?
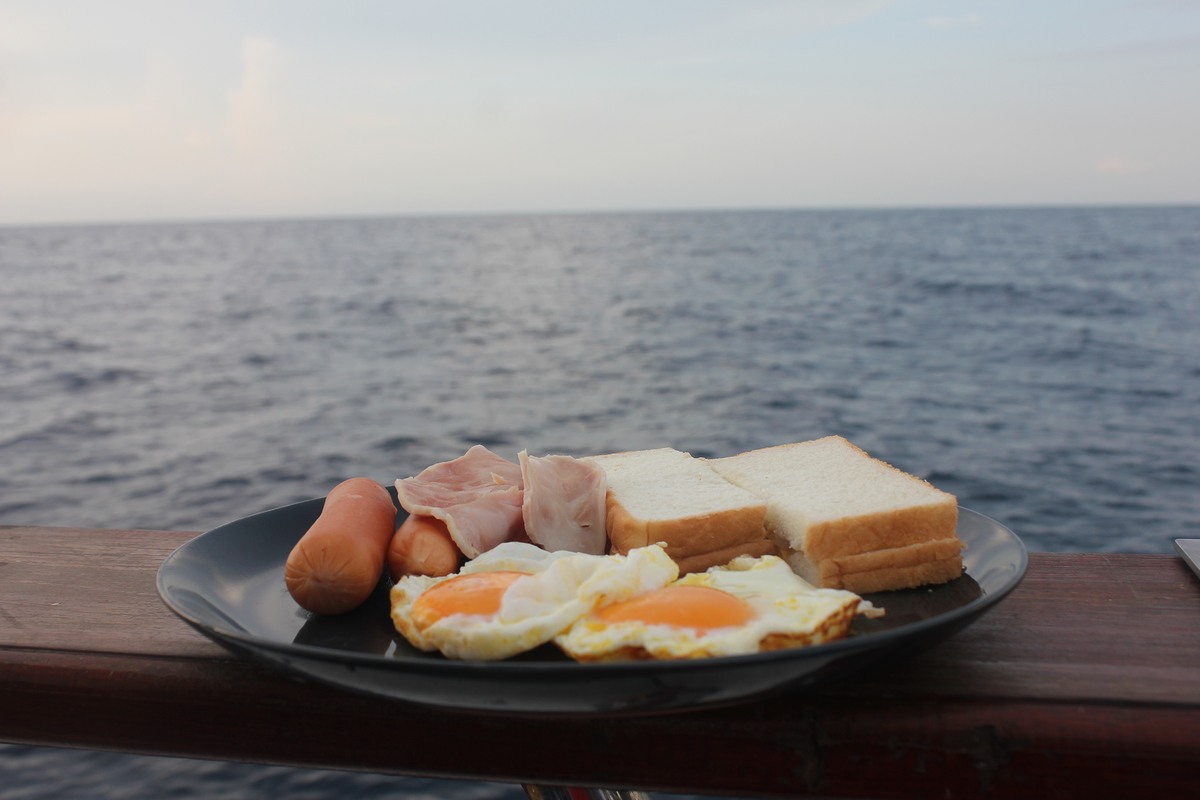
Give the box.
[0,206,1200,800]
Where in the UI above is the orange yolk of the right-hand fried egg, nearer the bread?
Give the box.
[595,585,754,630]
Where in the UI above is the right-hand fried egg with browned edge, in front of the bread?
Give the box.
[554,555,881,661]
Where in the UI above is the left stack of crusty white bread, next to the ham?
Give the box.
[590,447,776,572]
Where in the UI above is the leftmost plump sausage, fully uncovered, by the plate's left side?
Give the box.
[283,477,396,614]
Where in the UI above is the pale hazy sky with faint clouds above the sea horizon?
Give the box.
[0,0,1200,224]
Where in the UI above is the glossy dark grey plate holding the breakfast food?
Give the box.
[158,499,1028,715]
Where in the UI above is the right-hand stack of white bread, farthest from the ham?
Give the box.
[708,437,962,593]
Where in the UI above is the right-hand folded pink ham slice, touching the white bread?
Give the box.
[517,450,608,555]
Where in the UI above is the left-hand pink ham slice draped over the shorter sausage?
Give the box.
[396,445,524,558]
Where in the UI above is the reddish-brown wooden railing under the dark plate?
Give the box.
[0,527,1200,800]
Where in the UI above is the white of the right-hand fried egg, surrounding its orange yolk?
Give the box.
[554,555,877,661]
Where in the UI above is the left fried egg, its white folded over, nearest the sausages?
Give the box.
[391,542,679,661]
